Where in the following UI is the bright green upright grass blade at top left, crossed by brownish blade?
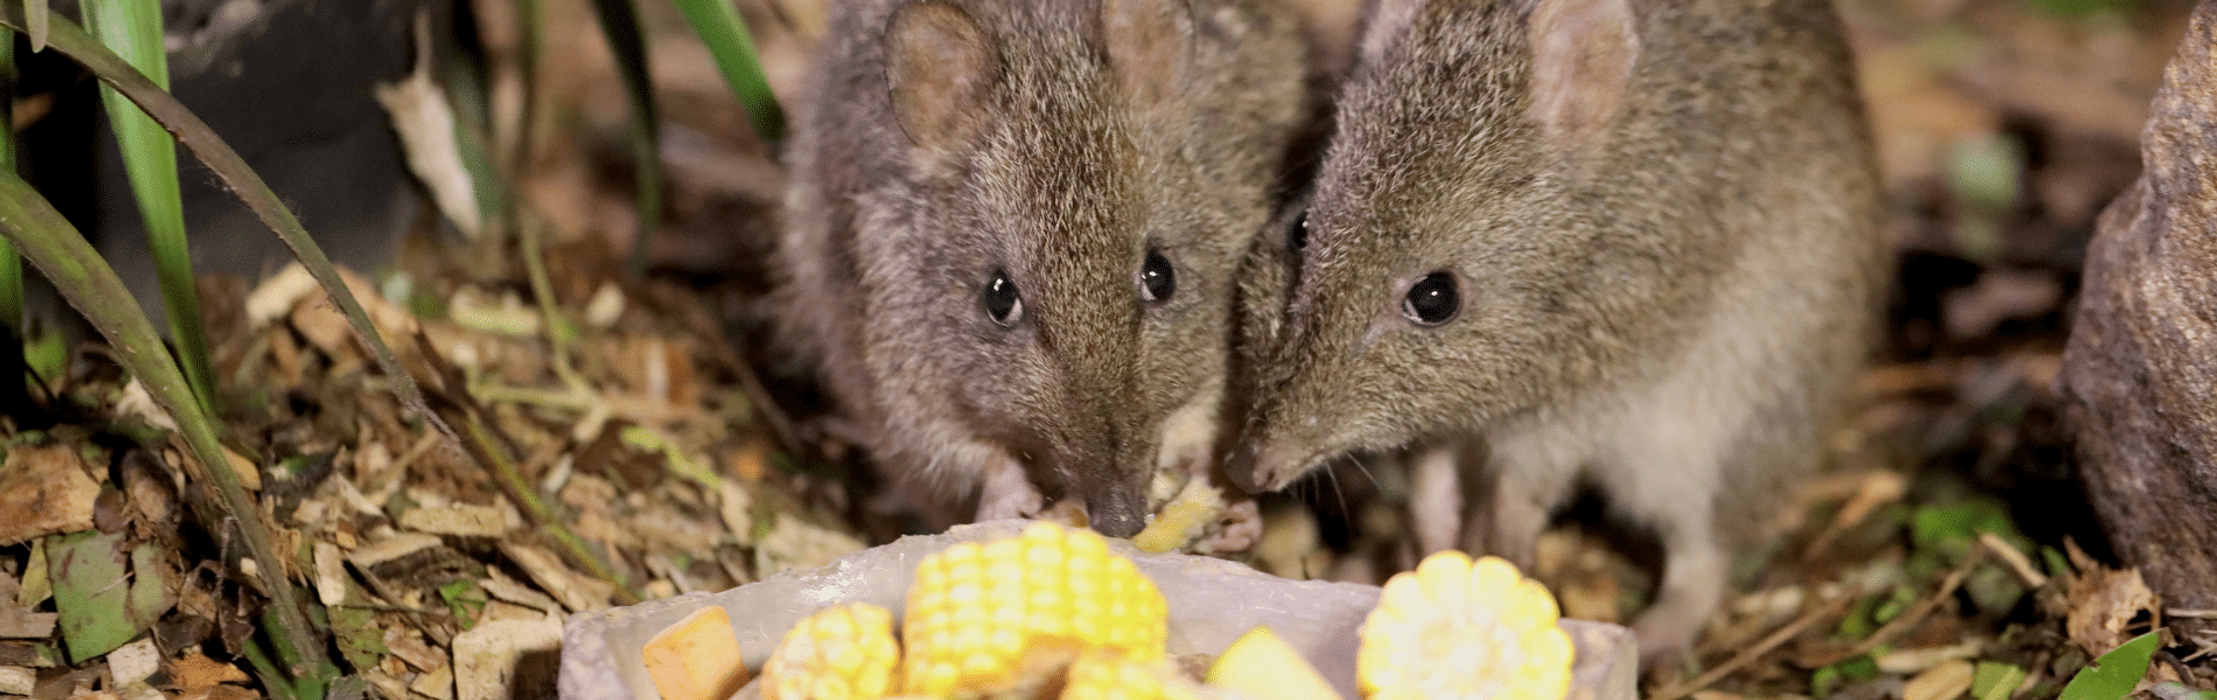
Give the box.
[84,0,215,410]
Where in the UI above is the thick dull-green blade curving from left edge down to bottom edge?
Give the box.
[0,172,335,678]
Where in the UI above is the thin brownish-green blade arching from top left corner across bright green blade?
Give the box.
[0,2,459,441]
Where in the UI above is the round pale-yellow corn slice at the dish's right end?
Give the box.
[1355,552,1572,700]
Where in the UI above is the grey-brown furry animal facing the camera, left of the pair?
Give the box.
[778,0,1304,534]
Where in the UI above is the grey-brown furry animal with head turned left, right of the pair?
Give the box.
[1226,0,1882,656]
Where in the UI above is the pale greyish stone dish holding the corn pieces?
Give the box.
[561,521,1638,700]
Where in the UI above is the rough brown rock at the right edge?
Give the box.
[2062,0,2217,629]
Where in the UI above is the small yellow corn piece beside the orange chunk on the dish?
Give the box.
[760,603,900,700]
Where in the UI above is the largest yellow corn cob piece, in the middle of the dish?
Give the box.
[900,523,1168,696]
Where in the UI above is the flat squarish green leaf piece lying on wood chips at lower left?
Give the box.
[47,532,140,665]
